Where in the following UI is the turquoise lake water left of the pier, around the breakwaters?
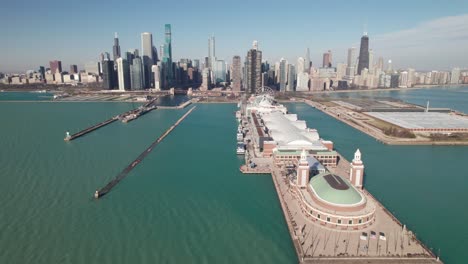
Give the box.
[0,103,297,263]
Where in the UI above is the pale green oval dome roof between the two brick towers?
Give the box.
[309,172,364,206]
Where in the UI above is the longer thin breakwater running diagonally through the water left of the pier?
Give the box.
[94,106,196,199]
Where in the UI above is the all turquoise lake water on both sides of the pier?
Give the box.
[0,88,468,263]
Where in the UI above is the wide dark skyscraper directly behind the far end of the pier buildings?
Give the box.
[246,40,262,93]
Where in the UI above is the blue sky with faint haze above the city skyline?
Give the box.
[0,0,468,72]
